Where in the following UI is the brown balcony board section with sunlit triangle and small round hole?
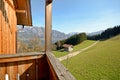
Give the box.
[18,60,36,80]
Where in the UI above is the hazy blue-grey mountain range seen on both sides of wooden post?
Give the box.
[17,26,69,45]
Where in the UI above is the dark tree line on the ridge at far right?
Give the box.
[87,25,120,40]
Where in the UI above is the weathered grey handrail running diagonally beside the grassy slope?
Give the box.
[46,53,76,80]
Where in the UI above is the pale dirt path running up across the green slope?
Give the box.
[58,41,99,61]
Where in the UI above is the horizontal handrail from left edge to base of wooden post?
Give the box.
[0,52,45,63]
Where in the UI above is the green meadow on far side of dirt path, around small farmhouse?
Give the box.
[53,40,95,57]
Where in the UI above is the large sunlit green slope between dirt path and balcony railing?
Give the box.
[62,35,120,80]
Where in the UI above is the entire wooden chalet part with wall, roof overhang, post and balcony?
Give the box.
[0,0,75,80]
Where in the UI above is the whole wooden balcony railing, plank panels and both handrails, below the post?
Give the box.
[0,52,75,80]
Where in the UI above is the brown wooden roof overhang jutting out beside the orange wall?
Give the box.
[13,0,32,26]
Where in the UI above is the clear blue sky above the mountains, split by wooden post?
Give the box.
[31,0,120,33]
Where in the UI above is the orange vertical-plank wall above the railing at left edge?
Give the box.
[0,0,17,54]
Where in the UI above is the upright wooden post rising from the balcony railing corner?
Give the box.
[45,0,52,52]
